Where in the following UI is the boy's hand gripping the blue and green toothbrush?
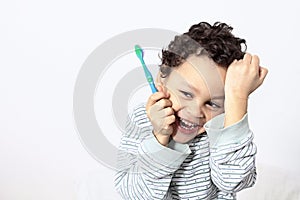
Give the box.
[146,86,175,146]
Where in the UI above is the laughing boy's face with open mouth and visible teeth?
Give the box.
[162,56,226,143]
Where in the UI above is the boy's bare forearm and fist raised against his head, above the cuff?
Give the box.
[224,53,268,127]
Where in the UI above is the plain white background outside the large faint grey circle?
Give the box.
[0,0,300,200]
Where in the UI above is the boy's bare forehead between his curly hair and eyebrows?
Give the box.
[170,55,226,93]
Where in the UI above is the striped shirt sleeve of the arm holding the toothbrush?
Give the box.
[115,105,191,200]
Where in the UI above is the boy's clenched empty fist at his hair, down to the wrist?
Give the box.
[225,53,268,99]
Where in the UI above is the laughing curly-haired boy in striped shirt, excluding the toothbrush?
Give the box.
[115,22,267,199]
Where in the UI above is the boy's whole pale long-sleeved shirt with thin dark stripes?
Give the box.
[115,106,256,200]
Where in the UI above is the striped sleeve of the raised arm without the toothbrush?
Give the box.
[204,114,257,195]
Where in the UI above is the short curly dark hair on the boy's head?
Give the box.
[160,22,247,77]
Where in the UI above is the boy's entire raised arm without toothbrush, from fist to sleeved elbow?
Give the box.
[206,54,268,193]
